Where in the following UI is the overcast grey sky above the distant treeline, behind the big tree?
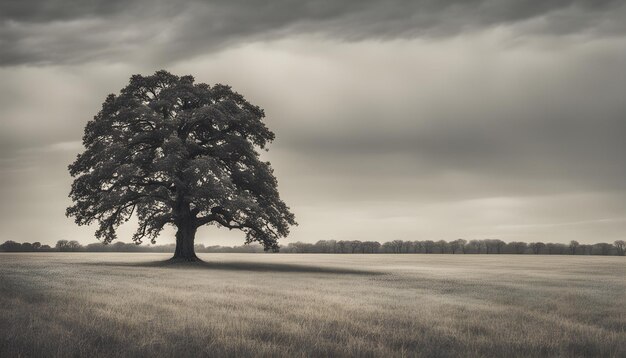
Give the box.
[0,0,626,245]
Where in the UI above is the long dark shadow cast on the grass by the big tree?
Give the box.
[84,260,384,276]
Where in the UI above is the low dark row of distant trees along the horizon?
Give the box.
[0,239,626,256]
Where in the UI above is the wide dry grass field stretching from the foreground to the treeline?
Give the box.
[0,253,626,357]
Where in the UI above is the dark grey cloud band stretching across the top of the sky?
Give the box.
[0,0,626,65]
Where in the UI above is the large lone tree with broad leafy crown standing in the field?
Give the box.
[66,71,296,261]
